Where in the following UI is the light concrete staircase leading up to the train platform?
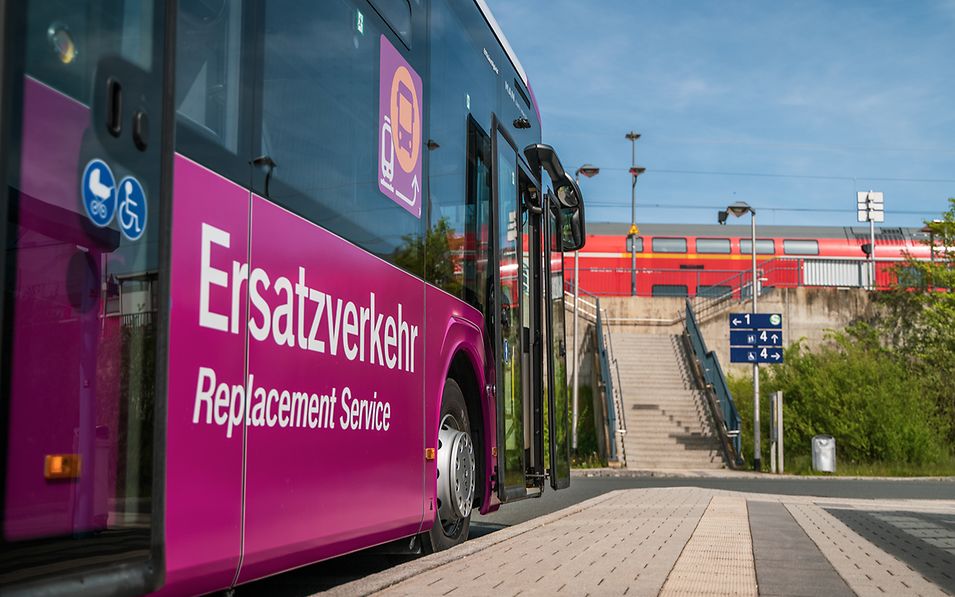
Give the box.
[613,330,724,470]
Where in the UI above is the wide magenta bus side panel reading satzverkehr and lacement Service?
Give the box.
[240,196,425,582]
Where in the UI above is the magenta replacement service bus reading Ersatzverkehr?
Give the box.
[0,0,584,595]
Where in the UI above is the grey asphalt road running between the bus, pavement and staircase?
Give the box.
[236,473,955,597]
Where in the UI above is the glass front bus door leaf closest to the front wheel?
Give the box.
[494,129,544,502]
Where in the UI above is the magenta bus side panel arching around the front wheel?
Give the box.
[424,286,500,529]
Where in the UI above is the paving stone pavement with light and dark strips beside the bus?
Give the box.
[332,487,955,596]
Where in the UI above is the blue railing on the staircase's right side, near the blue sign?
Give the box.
[686,300,743,466]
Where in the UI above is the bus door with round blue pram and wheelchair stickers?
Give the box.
[0,0,176,594]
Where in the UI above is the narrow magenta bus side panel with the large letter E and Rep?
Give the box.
[163,155,249,594]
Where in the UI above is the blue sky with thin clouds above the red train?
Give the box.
[487,0,955,226]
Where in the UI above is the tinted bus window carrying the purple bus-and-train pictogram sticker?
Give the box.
[255,0,427,275]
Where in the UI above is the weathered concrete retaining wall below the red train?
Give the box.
[600,288,873,373]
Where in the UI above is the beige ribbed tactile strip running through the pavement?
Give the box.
[660,496,757,597]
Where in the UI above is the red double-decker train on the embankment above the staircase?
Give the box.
[564,224,931,296]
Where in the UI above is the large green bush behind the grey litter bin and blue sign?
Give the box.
[730,326,951,472]
